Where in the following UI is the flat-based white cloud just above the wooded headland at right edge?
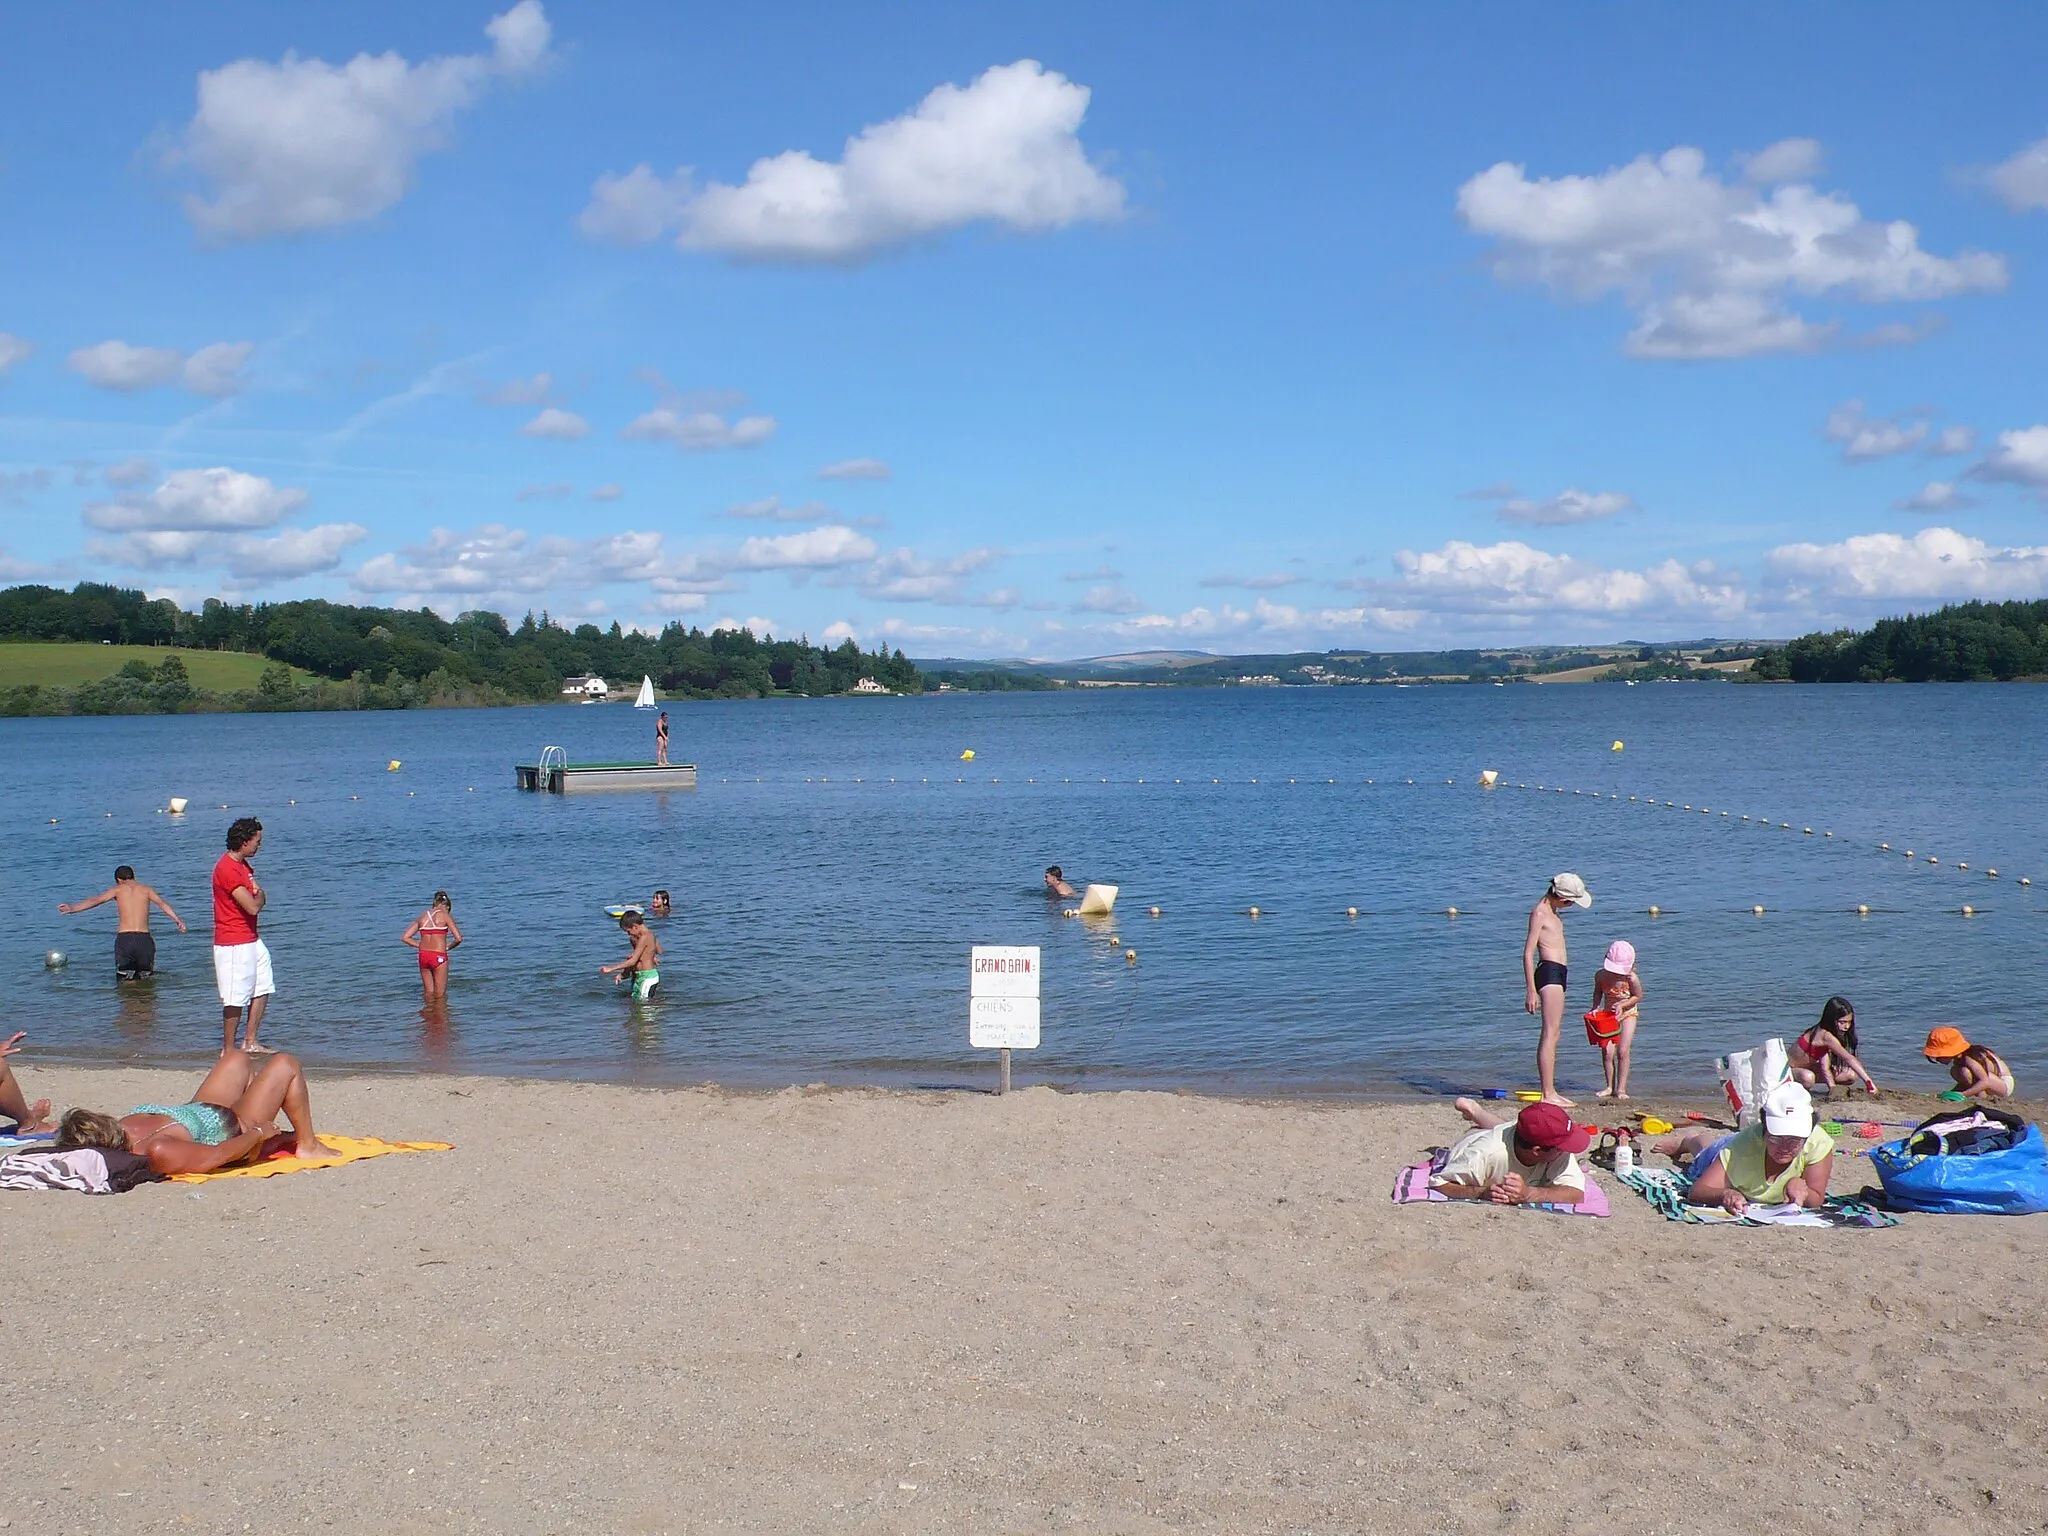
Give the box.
[1769,528,2048,604]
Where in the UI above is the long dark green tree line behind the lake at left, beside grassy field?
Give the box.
[0,582,924,713]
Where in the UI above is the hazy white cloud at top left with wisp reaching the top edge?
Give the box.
[170,0,549,240]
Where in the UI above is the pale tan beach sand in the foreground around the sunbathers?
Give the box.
[0,1057,2048,1536]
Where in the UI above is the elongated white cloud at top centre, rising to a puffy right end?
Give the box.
[582,59,1124,262]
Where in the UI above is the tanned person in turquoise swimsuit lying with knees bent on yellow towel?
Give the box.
[57,1051,334,1174]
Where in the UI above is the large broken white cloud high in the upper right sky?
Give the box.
[1458,145,2007,358]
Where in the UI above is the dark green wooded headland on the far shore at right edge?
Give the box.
[1751,602,2048,682]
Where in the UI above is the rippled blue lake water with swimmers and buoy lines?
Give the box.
[0,684,2048,1092]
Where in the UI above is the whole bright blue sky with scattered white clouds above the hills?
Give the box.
[0,0,2048,657]
